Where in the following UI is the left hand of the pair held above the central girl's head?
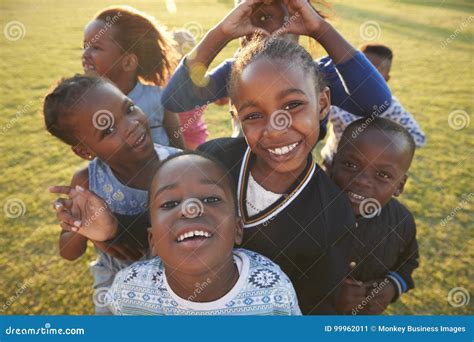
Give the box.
[218,0,273,40]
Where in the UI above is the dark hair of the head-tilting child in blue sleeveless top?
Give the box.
[43,75,111,146]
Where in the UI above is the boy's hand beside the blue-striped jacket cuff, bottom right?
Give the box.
[362,279,397,315]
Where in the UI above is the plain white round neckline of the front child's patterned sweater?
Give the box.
[163,250,250,311]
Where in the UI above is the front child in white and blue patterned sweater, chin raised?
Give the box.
[109,152,301,315]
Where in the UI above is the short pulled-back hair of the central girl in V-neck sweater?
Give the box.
[228,36,326,99]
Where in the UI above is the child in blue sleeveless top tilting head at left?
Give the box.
[43,76,177,313]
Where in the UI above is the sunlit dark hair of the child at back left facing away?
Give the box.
[94,6,179,86]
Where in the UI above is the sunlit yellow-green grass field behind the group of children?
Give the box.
[0,0,474,315]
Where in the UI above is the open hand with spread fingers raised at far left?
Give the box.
[49,186,118,241]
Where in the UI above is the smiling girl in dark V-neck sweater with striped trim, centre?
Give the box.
[199,38,354,314]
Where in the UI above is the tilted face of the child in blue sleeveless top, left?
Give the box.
[68,83,154,168]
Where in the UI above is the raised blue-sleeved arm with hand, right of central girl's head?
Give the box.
[284,0,391,116]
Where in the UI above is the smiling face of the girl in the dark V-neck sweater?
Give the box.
[234,58,330,176]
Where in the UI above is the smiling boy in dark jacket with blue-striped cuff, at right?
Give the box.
[331,118,418,314]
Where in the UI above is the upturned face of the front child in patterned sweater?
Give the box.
[149,155,242,274]
